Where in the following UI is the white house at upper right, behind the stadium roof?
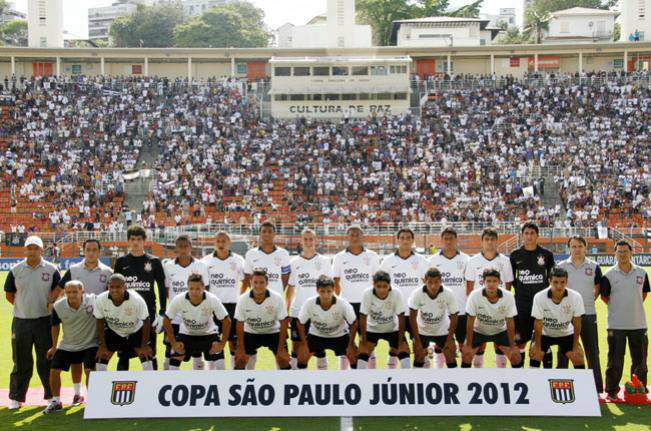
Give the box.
[543,7,619,44]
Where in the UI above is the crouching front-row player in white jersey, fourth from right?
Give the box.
[357,271,411,369]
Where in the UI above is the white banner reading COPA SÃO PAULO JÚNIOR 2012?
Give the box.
[84,368,601,419]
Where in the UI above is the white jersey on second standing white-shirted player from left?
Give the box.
[201,253,244,304]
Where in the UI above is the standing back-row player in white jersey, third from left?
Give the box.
[242,220,291,297]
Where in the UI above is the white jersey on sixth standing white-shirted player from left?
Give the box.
[380,252,429,315]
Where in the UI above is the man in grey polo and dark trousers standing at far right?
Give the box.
[600,240,651,401]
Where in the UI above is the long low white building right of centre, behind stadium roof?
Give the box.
[391,16,501,48]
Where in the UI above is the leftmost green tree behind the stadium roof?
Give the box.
[109,1,186,48]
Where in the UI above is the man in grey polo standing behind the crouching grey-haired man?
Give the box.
[55,238,113,406]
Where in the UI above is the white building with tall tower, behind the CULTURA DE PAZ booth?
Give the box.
[276,0,373,48]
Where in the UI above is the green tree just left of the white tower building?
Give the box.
[174,1,271,48]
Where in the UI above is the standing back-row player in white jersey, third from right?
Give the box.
[380,228,429,368]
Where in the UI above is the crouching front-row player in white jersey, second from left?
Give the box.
[164,274,231,370]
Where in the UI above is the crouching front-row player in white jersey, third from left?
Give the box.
[235,268,291,370]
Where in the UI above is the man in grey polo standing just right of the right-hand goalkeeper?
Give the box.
[558,236,604,394]
